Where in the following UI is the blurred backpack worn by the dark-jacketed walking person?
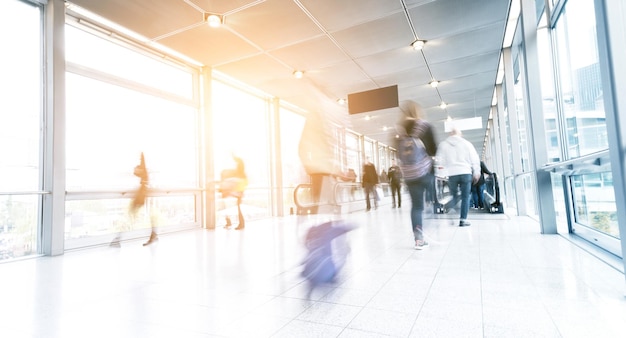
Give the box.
[397,135,432,180]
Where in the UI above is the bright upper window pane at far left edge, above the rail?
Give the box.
[0,0,42,192]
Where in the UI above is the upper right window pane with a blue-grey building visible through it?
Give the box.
[555,0,608,158]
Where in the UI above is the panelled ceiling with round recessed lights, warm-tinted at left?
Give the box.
[66,0,510,152]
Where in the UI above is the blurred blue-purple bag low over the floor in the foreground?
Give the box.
[302,221,353,298]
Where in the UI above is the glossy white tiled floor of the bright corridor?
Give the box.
[0,205,626,338]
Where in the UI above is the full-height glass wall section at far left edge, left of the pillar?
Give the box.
[0,0,44,260]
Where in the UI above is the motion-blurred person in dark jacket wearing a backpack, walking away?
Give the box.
[396,104,437,250]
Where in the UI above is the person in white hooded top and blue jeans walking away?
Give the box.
[437,128,480,227]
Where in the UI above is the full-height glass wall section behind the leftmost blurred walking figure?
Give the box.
[65,21,200,248]
